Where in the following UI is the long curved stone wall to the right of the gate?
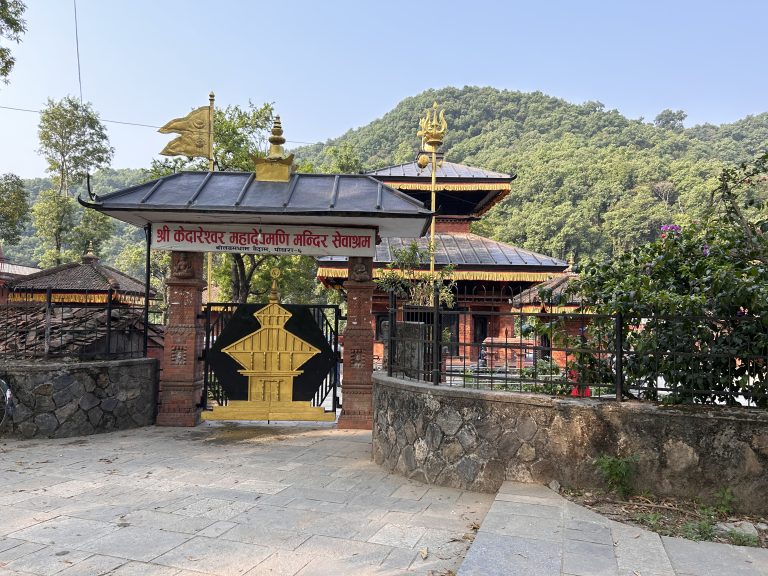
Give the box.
[373,374,768,513]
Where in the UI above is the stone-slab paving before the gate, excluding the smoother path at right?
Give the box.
[0,423,493,576]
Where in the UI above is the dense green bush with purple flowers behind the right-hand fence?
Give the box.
[576,155,768,407]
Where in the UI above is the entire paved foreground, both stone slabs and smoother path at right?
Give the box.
[0,422,768,576]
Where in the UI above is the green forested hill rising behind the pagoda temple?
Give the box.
[295,87,768,260]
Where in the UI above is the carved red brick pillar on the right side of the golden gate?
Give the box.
[338,257,376,430]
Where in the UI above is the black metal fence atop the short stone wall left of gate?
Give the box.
[0,289,162,360]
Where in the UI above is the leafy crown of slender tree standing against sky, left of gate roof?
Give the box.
[38,96,114,194]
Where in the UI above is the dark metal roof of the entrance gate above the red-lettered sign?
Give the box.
[79,172,432,237]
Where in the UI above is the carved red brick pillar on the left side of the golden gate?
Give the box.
[157,251,205,426]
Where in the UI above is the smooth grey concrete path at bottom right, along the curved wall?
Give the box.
[458,482,768,576]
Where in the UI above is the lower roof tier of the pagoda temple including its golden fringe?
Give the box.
[317,233,568,282]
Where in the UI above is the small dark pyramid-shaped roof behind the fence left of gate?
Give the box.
[9,258,144,296]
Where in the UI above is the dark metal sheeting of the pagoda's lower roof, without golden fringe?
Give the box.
[318,233,568,272]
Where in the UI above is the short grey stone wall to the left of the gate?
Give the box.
[0,358,157,438]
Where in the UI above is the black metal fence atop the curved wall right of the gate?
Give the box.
[383,286,768,407]
